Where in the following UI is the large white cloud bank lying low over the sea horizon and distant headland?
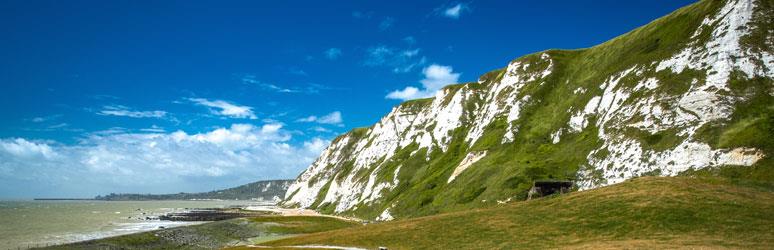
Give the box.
[0,123,328,197]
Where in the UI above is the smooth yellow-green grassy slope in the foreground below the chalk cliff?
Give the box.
[266,177,774,249]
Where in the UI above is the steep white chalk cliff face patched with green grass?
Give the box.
[284,0,774,220]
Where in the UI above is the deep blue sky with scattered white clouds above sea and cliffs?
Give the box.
[0,0,693,198]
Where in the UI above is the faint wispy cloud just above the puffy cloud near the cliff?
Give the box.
[363,45,427,73]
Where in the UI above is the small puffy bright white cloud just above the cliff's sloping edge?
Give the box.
[385,64,460,100]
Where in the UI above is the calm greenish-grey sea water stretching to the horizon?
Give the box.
[0,201,264,250]
